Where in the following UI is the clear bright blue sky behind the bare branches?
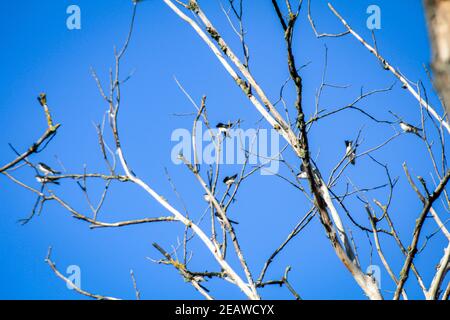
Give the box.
[0,0,445,299]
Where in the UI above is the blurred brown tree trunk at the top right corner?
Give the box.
[424,0,450,113]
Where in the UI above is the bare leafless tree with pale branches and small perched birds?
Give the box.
[0,0,450,300]
